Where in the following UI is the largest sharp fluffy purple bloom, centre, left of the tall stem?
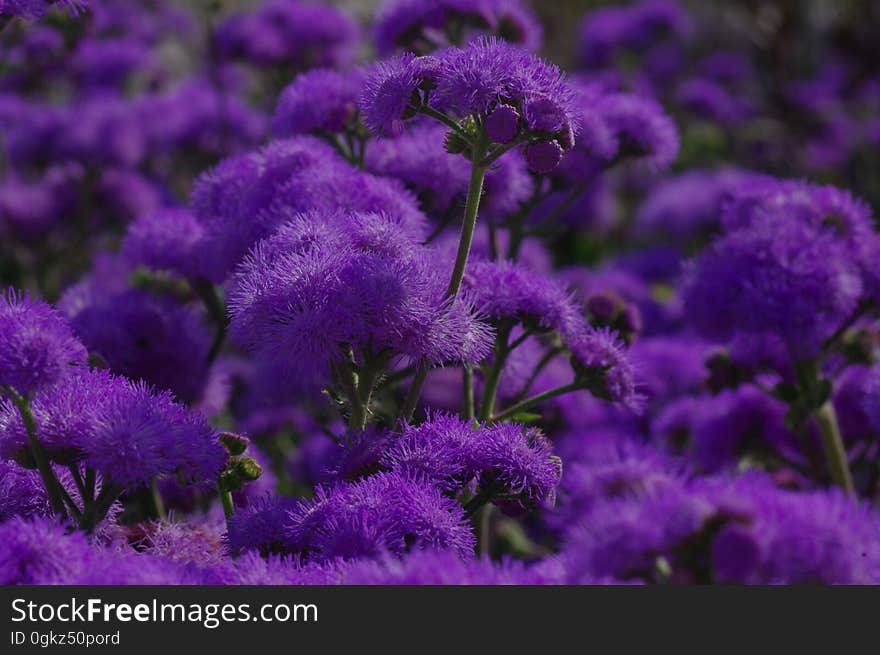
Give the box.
[229,212,489,392]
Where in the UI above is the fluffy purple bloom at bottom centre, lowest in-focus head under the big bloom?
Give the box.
[286,473,475,559]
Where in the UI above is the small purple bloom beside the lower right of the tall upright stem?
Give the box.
[462,260,586,334]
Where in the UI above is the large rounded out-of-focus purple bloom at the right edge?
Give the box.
[682,220,862,358]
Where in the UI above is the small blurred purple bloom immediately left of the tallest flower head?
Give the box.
[273,69,363,137]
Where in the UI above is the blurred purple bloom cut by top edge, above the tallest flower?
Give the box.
[373,0,542,57]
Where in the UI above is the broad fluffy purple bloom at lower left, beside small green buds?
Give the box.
[0,370,226,487]
